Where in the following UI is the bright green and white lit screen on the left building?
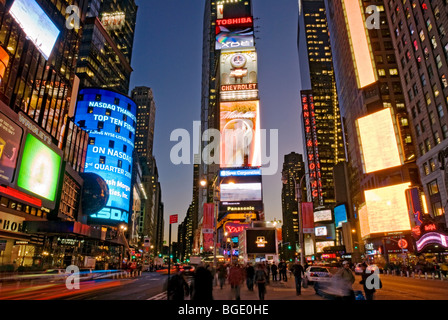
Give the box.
[17,133,62,202]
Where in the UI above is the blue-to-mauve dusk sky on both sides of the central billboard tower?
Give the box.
[131,0,303,241]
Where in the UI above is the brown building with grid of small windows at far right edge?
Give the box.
[384,1,448,228]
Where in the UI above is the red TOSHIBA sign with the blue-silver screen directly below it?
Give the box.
[215,17,255,50]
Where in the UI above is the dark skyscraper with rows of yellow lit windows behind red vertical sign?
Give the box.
[298,0,345,209]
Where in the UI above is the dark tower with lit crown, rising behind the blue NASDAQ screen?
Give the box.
[76,0,138,95]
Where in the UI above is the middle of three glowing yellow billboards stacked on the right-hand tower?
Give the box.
[356,108,403,173]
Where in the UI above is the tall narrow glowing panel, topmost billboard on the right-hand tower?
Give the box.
[342,0,377,88]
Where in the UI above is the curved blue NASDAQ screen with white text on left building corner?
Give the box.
[75,88,137,226]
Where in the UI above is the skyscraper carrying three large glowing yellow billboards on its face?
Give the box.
[325,0,420,259]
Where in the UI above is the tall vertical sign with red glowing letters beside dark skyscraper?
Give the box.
[302,91,323,206]
